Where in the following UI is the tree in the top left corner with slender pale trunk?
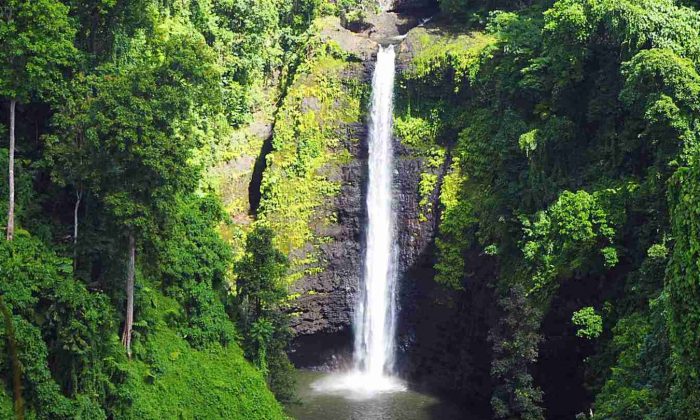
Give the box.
[0,0,76,240]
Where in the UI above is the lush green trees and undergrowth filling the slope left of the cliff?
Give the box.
[0,0,320,419]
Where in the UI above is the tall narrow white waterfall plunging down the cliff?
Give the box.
[354,45,397,378]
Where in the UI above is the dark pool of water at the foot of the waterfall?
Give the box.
[287,370,479,420]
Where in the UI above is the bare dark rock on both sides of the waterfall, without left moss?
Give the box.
[291,19,496,410]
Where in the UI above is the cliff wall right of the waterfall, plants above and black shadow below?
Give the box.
[395,23,498,417]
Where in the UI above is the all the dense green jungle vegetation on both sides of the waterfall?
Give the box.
[0,0,700,419]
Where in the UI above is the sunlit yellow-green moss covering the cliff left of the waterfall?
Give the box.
[254,18,367,283]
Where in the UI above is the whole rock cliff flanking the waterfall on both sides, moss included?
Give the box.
[249,9,495,414]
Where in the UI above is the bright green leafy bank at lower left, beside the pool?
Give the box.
[114,306,285,419]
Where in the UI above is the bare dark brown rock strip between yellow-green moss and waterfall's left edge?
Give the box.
[292,115,367,367]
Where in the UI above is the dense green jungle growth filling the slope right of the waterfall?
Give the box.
[404,0,700,419]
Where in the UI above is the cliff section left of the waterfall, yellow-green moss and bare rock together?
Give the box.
[258,17,374,364]
